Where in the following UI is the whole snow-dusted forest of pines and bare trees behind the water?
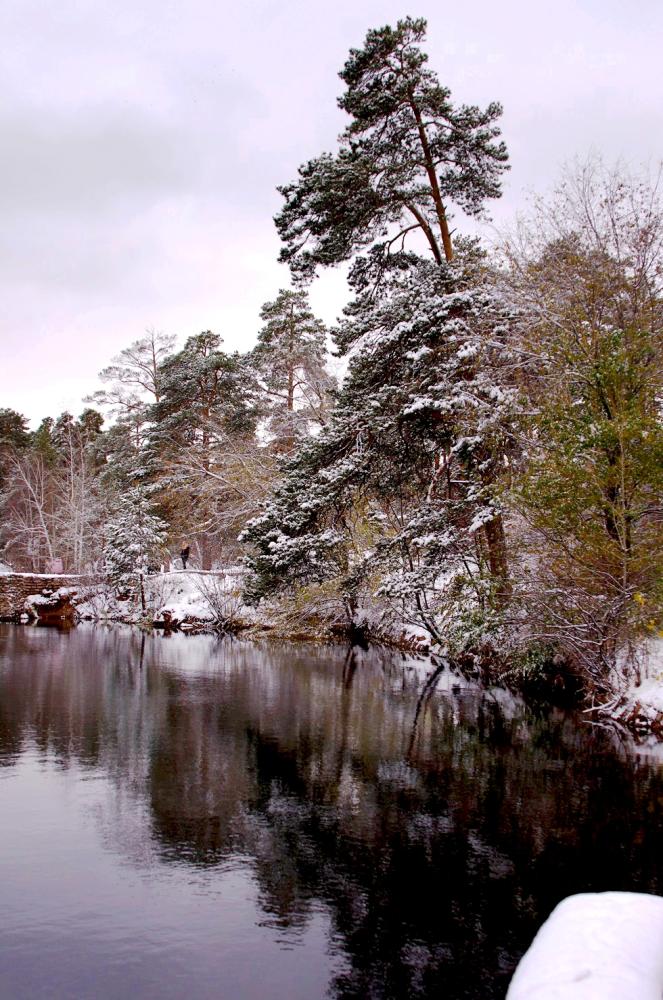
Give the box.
[0,18,663,698]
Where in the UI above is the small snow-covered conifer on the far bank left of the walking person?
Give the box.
[104,487,166,610]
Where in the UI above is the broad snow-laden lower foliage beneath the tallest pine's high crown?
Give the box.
[243,257,519,639]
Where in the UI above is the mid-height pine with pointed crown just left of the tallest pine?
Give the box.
[249,289,334,453]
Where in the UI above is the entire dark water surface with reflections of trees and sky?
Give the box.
[0,626,663,1000]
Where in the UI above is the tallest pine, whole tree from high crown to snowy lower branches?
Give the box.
[244,18,517,634]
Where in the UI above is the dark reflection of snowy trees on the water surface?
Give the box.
[0,626,663,998]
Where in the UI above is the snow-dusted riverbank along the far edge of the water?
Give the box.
[5,566,663,740]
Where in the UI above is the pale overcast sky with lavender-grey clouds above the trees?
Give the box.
[0,0,663,423]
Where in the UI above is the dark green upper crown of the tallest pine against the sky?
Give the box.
[276,17,507,278]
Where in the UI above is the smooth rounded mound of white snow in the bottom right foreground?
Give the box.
[507,892,663,1000]
